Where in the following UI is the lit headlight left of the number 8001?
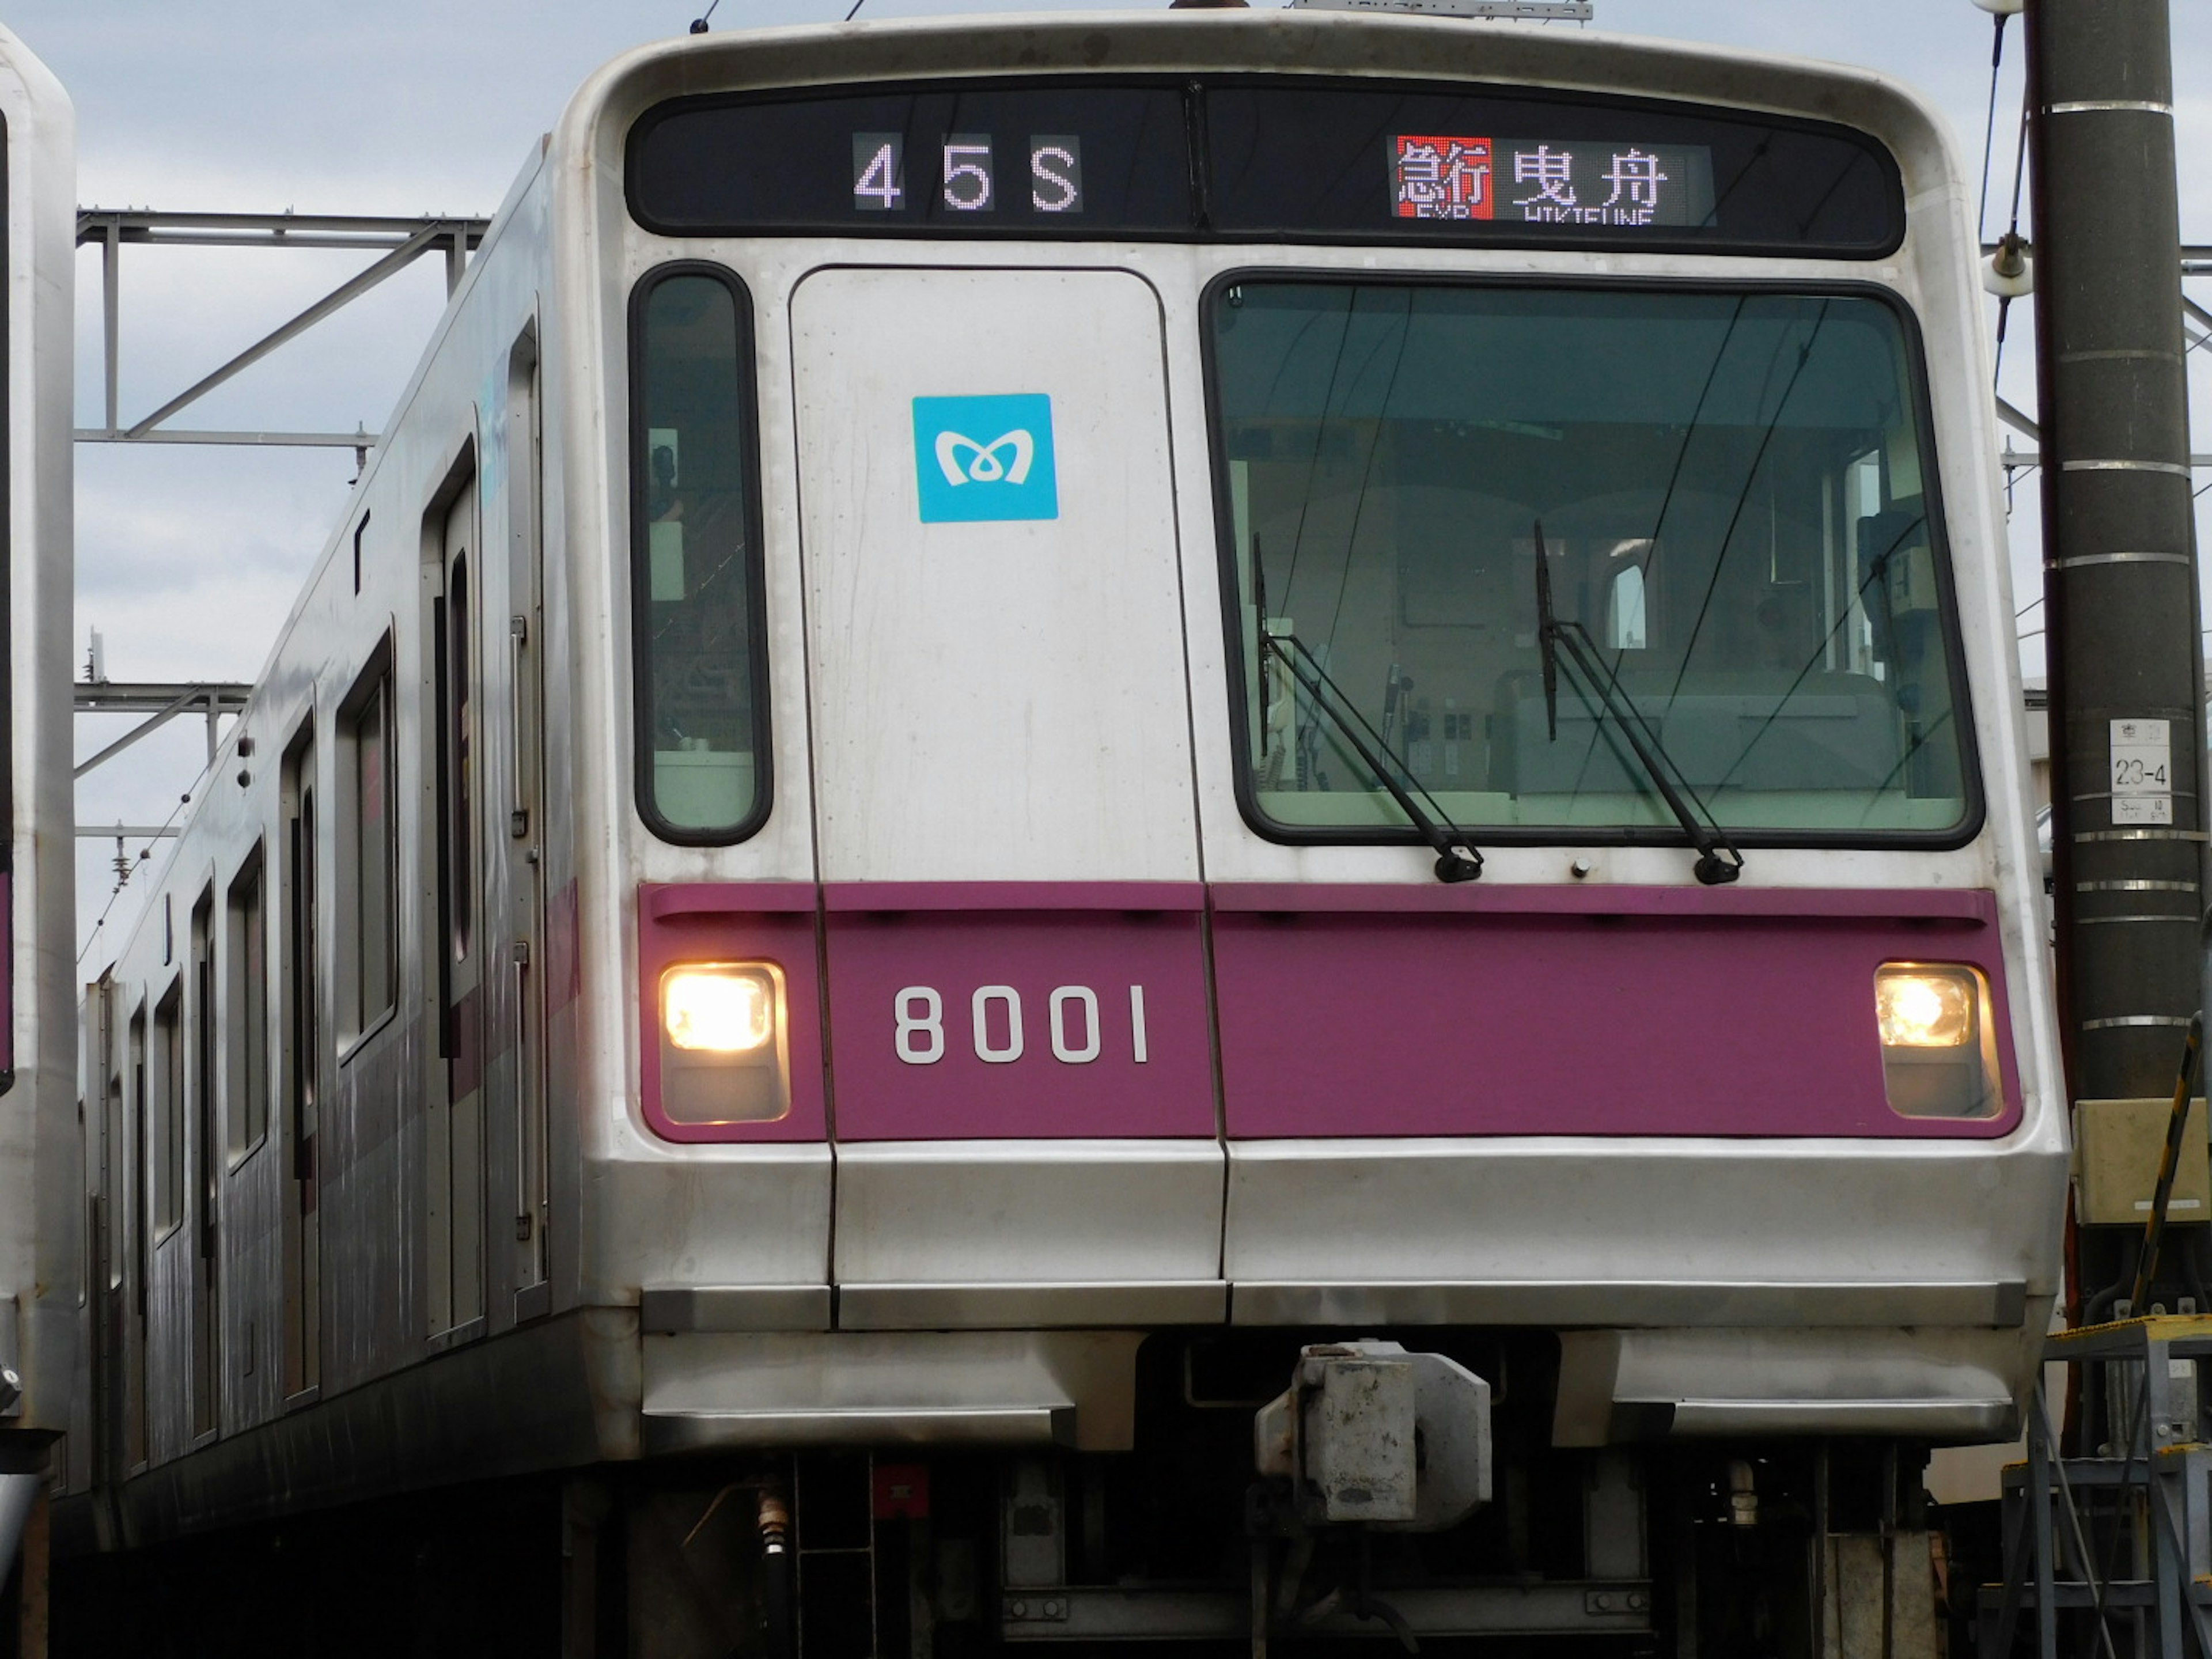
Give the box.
[659,962,792,1124]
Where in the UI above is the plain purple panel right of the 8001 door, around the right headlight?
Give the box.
[1212,882,2020,1139]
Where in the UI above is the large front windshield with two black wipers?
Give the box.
[1210,279,1971,838]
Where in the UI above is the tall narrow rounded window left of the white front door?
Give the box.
[630,266,770,845]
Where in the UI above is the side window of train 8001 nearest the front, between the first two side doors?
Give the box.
[339,635,398,1037]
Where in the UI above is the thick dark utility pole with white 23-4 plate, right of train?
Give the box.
[2026,0,2205,1319]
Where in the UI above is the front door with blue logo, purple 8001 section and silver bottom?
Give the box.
[792,270,1221,1327]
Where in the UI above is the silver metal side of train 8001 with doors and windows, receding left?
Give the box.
[75,149,641,1537]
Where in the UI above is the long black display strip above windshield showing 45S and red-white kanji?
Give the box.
[628,77,1904,256]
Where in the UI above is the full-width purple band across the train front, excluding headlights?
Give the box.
[639,882,2020,1141]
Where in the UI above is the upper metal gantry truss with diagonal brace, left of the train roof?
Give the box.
[77,208,491,458]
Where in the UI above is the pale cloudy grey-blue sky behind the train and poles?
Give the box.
[17,0,2212,971]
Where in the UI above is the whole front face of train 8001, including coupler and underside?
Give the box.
[555,11,2064,1654]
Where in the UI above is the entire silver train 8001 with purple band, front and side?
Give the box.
[55,7,2066,1659]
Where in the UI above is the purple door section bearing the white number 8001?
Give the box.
[823,882,1219,1141]
